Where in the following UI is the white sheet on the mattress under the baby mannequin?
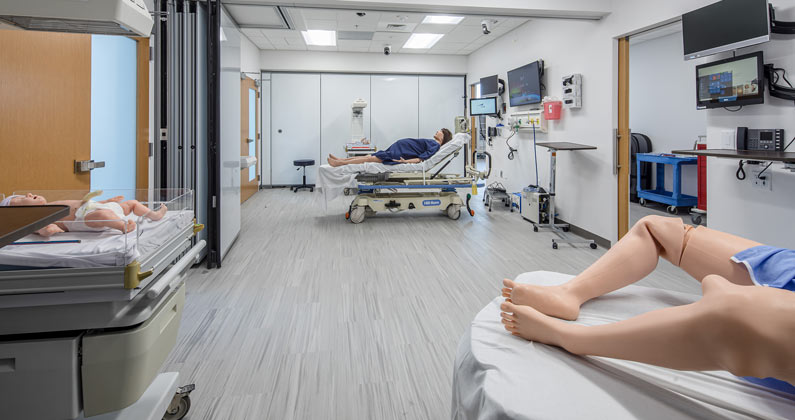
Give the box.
[0,211,194,268]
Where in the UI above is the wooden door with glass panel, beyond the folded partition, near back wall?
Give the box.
[240,77,260,203]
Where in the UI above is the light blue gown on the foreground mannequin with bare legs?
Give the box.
[732,245,795,394]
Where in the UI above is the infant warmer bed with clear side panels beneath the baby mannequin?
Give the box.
[0,190,205,420]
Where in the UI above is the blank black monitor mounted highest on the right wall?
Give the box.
[682,0,770,60]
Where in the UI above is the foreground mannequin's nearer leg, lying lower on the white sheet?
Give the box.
[501,275,795,382]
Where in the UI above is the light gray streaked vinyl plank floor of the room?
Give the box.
[163,189,699,420]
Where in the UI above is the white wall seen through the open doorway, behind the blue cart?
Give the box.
[629,31,707,196]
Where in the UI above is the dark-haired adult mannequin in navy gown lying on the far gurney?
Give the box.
[328,128,453,167]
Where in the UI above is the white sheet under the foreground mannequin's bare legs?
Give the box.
[452,271,795,419]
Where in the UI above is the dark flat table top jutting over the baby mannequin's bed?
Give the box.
[0,205,69,248]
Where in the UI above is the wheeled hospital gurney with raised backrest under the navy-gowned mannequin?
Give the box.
[316,133,491,223]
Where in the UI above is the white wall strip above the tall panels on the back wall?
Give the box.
[260,50,467,74]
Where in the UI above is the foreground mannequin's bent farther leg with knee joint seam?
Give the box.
[502,216,760,320]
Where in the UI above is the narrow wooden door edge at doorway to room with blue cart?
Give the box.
[613,37,630,239]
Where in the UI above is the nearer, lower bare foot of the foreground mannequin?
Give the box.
[500,302,567,346]
